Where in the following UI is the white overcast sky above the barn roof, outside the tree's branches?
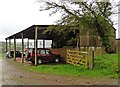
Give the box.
[0,0,118,41]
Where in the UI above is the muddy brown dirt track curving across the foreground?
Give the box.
[0,59,118,85]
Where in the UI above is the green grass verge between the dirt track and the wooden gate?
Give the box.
[25,54,118,78]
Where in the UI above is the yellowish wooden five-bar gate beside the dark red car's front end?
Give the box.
[66,50,89,68]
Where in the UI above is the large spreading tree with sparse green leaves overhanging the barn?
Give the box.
[40,0,114,53]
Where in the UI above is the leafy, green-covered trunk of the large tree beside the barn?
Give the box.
[97,16,115,53]
